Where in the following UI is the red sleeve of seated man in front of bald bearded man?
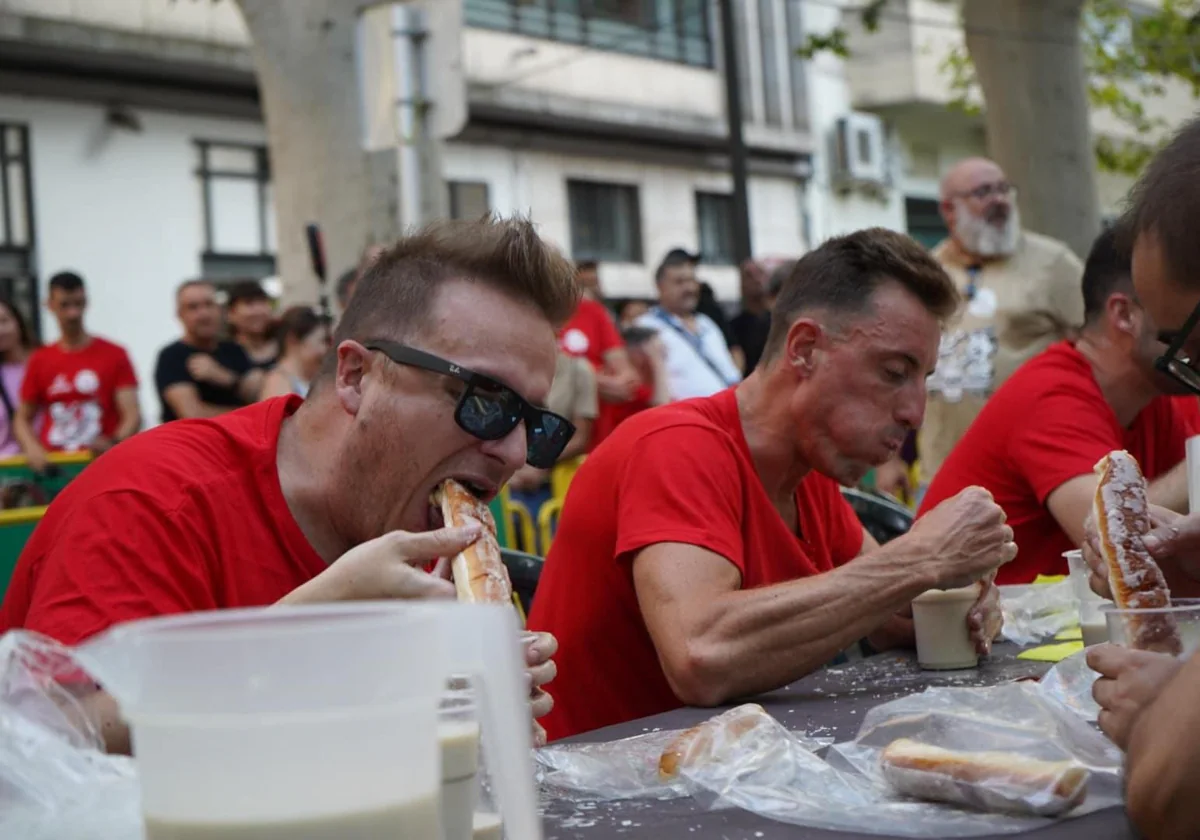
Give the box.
[1008,389,1122,504]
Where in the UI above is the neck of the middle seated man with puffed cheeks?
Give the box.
[736,366,811,504]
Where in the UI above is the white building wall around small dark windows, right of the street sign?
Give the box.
[444,144,805,300]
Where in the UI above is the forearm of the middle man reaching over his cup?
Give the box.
[683,540,935,704]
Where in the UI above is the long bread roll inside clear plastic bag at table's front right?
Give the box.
[880,738,1090,816]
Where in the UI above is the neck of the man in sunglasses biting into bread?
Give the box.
[275,398,352,563]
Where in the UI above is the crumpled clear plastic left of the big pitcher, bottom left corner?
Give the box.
[0,631,143,840]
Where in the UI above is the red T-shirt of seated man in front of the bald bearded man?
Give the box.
[918,342,1200,583]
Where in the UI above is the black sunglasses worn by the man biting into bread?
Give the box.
[364,341,575,469]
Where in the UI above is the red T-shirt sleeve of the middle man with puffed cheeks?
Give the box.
[617,426,745,574]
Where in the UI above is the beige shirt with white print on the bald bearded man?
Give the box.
[918,230,1084,484]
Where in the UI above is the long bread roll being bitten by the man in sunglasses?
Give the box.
[433,479,512,604]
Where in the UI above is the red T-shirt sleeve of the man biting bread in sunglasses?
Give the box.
[24,491,217,644]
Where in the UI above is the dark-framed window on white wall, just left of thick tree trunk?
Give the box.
[196,140,275,280]
